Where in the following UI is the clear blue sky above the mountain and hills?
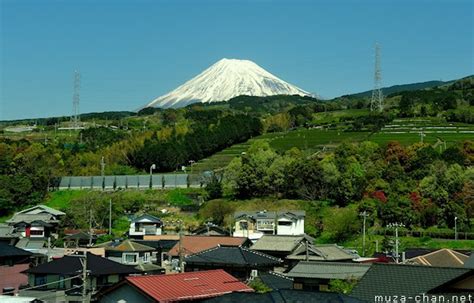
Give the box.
[0,0,474,120]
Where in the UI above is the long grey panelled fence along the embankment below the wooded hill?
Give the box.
[52,174,203,190]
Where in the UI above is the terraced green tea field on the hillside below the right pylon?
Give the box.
[193,119,474,173]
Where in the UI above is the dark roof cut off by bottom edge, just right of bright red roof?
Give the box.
[203,289,366,303]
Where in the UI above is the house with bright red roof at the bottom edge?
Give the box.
[99,269,253,303]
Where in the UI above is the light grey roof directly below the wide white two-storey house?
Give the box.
[251,235,314,253]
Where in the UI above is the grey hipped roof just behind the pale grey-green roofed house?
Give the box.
[287,244,354,261]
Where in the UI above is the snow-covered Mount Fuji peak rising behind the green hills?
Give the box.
[145,58,311,108]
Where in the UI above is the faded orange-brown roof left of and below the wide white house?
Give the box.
[168,236,248,257]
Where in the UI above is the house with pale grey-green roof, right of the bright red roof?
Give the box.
[287,261,371,291]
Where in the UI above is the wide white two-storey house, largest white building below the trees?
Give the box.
[233,210,306,240]
